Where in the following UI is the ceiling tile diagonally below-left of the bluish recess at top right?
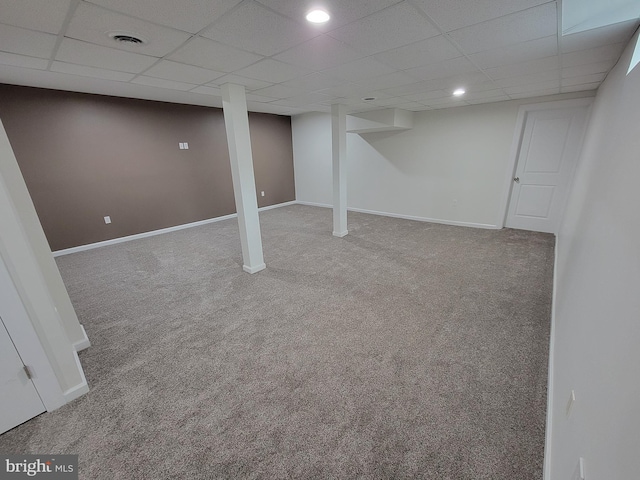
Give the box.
[469,35,558,68]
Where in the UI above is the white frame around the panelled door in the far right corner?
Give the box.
[496,97,595,229]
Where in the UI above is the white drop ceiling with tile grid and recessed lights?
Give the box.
[0,0,638,115]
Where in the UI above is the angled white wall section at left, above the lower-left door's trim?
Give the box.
[0,122,87,402]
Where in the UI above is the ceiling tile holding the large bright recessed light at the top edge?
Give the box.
[258,0,402,31]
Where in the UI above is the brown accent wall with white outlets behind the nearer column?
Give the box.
[0,85,295,251]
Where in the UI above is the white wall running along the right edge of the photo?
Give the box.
[547,34,640,480]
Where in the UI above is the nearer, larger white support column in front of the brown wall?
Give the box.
[222,83,266,273]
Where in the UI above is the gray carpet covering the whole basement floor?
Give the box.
[0,205,554,480]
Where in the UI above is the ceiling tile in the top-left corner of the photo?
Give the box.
[0,0,71,35]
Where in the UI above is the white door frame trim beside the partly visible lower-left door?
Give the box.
[0,253,67,412]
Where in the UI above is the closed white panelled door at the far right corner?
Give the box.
[506,106,589,233]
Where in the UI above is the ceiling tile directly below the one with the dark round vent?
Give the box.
[56,38,158,73]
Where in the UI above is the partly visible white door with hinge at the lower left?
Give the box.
[0,319,45,433]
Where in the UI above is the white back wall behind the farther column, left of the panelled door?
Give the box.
[292,94,589,227]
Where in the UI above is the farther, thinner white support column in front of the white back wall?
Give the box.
[331,104,349,237]
